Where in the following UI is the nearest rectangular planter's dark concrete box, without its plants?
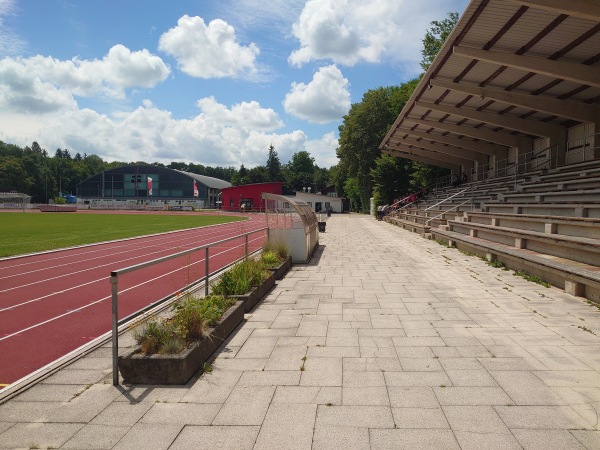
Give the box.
[119,301,244,384]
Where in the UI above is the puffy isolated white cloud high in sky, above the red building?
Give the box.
[159,15,260,78]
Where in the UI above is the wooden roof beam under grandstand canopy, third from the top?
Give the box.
[431,79,600,123]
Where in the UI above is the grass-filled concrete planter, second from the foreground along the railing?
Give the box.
[211,259,275,312]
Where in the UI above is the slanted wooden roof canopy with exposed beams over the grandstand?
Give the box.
[380,0,600,180]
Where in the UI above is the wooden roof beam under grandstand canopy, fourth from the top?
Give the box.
[415,102,565,137]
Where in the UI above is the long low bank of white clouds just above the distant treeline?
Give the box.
[0,98,335,167]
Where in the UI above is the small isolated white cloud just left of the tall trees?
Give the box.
[283,65,350,123]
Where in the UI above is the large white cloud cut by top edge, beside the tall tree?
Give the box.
[288,0,461,72]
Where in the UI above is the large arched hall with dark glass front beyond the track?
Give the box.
[77,164,231,208]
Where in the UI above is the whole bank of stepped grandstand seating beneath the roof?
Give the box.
[385,159,600,303]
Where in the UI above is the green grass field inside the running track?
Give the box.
[0,212,244,257]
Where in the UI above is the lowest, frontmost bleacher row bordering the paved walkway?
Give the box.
[430,229,600,302]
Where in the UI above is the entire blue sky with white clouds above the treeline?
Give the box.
[0,0,468,168]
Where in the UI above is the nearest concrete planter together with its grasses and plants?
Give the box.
[119,295,244,384]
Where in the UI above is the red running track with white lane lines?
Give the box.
[0,216,266,387]
